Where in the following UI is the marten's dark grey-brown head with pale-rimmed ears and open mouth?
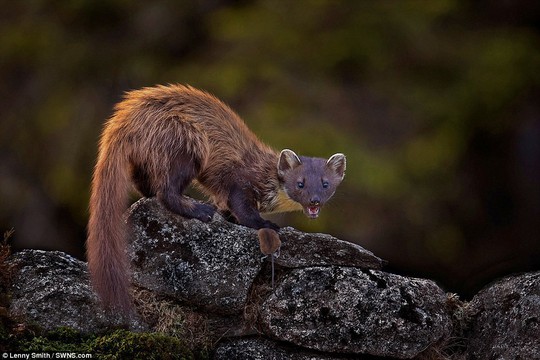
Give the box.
[277,149,346,219]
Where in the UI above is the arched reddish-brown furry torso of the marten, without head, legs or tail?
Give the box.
[106,85,277,195]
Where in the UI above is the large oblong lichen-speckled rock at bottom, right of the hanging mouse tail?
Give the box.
[260,267,451,358]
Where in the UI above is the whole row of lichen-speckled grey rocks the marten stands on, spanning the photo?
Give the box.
[4,199,540,359]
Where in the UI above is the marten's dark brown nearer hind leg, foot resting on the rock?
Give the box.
[157,151,216,222]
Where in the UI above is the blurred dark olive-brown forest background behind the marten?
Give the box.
[0,0,540,298]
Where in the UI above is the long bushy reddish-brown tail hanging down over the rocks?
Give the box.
[86,138,132,314]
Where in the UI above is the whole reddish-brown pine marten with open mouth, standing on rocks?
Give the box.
[87,85,345,313]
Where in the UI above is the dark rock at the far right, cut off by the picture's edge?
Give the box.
[467,272,540,359]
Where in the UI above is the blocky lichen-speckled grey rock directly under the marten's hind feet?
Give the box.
[128,199,262,314]
